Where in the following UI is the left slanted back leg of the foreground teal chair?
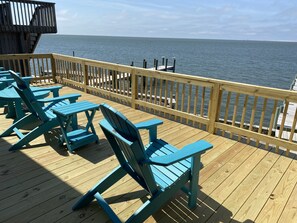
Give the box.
[72,166,127,210]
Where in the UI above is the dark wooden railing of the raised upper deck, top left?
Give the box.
[0,0,57,33]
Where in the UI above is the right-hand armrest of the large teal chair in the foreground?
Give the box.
[144,140,213,166]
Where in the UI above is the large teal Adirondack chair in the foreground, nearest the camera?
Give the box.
[73,104,212,222]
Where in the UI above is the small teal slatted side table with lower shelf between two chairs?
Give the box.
[52,101,99,153]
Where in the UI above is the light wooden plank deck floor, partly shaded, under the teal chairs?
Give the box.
[0,87,297,223]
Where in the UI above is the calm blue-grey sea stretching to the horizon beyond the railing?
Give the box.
[35,35,297,89]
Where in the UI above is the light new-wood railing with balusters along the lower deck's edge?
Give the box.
[0,54,297,154]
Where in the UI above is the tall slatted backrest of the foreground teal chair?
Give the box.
[100,104,158,194]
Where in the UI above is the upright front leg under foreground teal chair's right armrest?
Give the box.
[188,154,201,208]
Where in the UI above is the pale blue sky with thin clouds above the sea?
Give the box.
[49,0,297,42]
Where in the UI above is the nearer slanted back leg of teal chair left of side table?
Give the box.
[9,121,58,151]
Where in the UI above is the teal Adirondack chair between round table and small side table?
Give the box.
[0,72,81,151]
